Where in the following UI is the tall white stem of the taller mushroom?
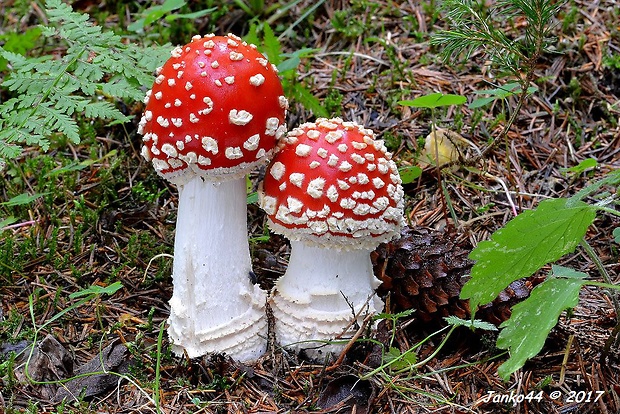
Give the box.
[168,176,267,361]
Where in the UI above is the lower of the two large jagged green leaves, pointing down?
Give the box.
[497,277,586,381]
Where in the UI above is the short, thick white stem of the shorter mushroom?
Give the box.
[271,241,383,359]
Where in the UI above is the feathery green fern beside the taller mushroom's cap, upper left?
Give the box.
[0,0,171,161]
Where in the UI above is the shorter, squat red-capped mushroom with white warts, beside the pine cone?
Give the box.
[259,118,404,359]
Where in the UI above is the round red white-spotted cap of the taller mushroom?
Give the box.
[138,34,288,183]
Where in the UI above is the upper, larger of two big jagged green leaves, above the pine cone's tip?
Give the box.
[461,198,596,309]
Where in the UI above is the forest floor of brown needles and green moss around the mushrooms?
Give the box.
[0,0,620,414]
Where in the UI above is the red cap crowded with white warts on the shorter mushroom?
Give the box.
[260,118,403,250]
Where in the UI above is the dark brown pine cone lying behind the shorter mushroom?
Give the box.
[371,227,532,325]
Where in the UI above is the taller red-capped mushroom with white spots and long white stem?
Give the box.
[138,34,288,361]
